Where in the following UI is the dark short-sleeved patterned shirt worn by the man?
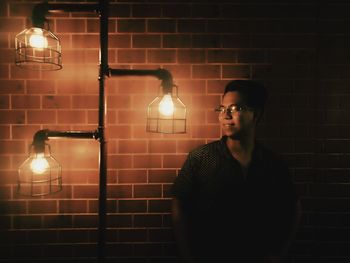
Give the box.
[172,136,297,262]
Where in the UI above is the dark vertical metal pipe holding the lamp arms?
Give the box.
[98,0,108,263]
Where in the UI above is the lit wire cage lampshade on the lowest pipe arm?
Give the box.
[17,144,62,196]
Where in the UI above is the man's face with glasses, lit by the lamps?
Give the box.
[219,91,256,140]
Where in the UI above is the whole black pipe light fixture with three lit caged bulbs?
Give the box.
[15,0,186,262]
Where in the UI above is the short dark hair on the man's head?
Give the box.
[223,80,268,119]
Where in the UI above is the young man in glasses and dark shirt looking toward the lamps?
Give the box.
[172,80,299,263]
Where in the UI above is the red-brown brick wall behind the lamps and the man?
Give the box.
[0,0,350,263]
